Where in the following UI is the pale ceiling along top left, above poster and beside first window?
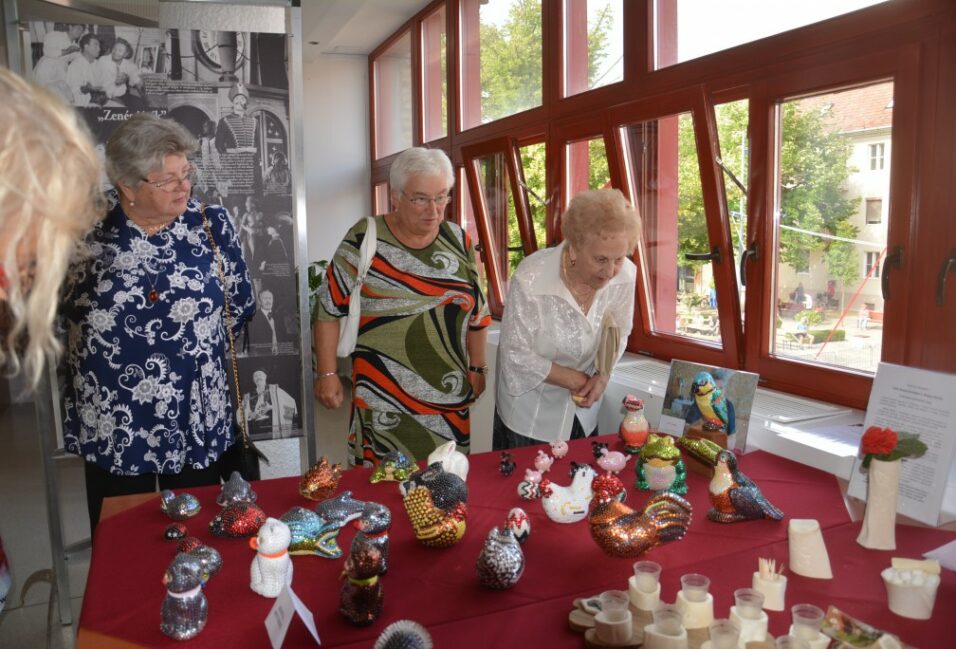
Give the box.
[18,0,430,62]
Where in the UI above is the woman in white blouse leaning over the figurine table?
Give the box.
[492,189,641,449]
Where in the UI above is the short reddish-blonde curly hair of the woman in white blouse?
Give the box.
[561,189,641,252]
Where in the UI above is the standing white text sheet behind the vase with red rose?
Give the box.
[847,363,956,525]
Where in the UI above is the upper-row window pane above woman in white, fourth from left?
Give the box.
[564,0,624,97]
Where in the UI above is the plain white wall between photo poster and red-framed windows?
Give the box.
[303,56,372,262]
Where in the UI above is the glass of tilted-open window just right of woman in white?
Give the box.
[622,113,720,344]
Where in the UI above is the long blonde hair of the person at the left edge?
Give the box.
[0,68,105,386]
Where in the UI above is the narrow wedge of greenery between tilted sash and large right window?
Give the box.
[706,99,750,317]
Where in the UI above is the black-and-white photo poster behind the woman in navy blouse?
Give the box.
[29,22,309,440]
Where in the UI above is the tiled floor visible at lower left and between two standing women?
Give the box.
[0,394,348,649]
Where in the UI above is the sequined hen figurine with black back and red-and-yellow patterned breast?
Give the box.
[401,464,468,548]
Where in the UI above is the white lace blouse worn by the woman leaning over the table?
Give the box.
[495,243,637,442]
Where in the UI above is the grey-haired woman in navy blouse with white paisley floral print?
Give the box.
[64,113,256,528]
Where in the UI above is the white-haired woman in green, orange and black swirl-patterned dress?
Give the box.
[315,148,491,465]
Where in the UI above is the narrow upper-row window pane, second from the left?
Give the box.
[421,5,448,142]
